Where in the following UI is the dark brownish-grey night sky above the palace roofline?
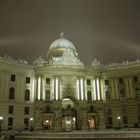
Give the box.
[0,0,140,64]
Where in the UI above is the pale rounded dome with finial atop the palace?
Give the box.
[47,33,77,61]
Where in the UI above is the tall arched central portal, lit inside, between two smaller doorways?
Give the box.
[61,98,77,131]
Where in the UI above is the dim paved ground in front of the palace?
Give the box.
[4,129,140,140]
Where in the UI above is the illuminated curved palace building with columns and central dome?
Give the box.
[0,33,140,131]
